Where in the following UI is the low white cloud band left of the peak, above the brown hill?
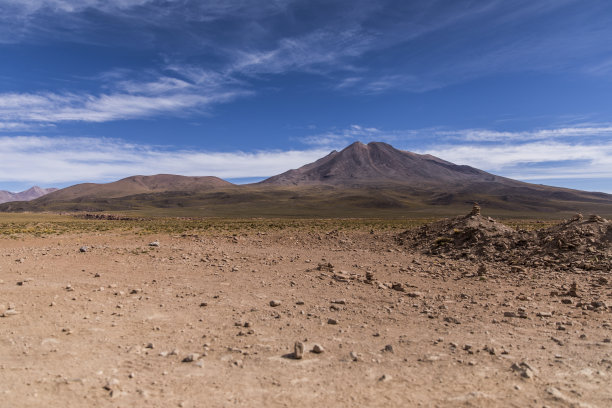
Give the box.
[0,136,329,186]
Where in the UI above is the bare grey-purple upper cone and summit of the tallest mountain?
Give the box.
[261,142,506,187]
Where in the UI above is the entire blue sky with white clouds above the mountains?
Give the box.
[0,0,612,193]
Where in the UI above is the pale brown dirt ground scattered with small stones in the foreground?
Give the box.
[0,221,612,407]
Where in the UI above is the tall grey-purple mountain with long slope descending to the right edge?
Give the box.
[260,142,612,206]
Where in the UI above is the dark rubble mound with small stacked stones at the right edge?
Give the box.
[396,209,612,270]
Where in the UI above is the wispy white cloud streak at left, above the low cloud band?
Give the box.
[0,66,250,126]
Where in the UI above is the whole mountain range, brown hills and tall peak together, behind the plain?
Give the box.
[0,142,612,217]
